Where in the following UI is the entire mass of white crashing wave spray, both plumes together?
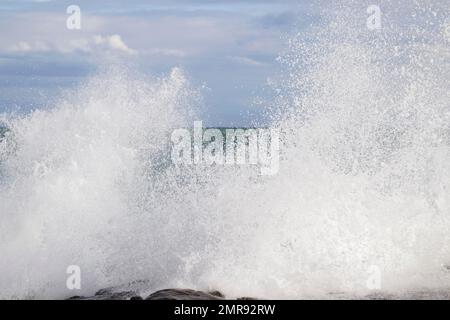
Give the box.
[0,1,450,299]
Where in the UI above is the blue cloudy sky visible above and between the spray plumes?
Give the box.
[0,0,314,125]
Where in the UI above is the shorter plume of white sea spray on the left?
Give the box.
[0,65,199,298]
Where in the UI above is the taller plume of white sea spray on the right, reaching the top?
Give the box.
[186,1,450,298]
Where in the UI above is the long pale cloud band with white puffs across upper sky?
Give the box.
[0,8,282,58]
